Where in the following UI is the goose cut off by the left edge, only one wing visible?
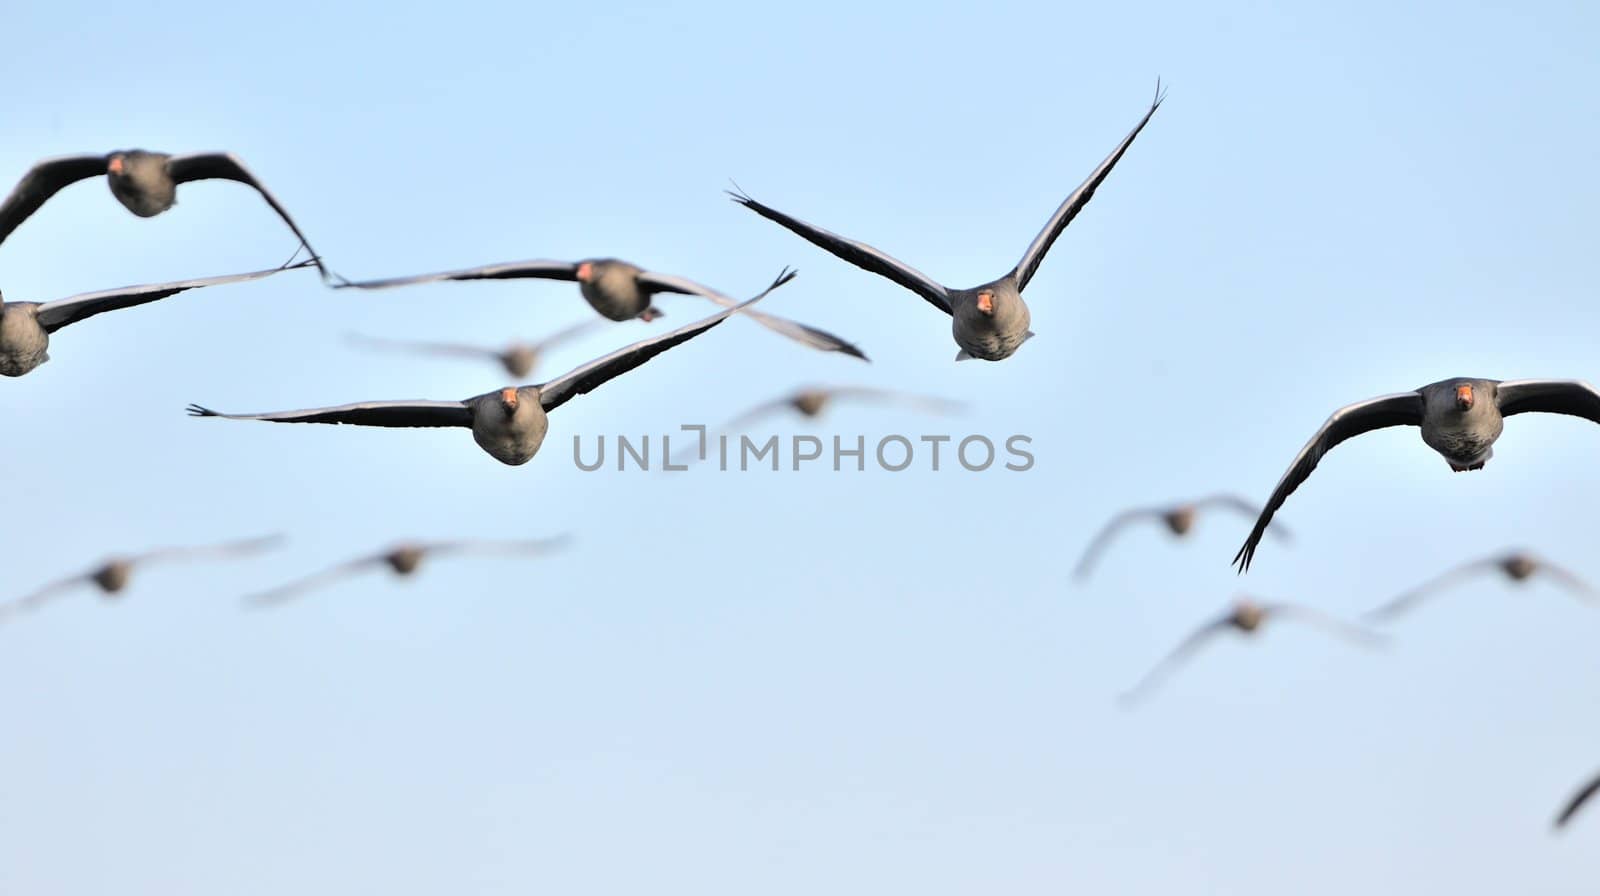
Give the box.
[0,261,310,376]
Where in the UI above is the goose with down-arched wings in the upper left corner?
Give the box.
[0,149,330,277]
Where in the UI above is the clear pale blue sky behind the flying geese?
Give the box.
[0,2,1600,896]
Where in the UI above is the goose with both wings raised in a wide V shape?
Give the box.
[730,85,1163,362]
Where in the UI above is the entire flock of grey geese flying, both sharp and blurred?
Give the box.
[0,86,1600,826]
